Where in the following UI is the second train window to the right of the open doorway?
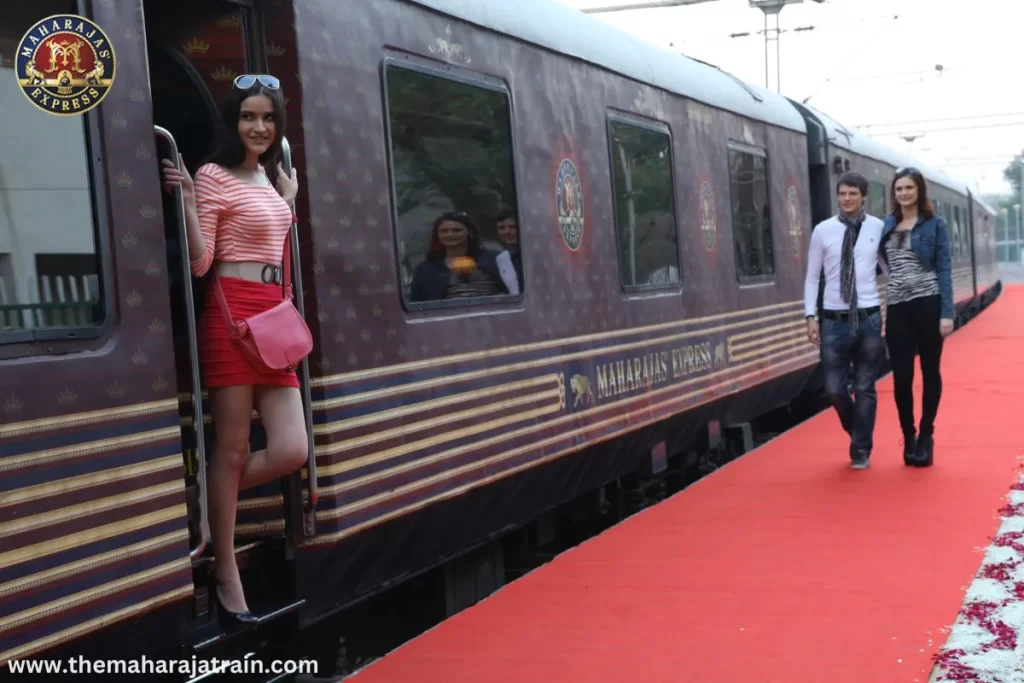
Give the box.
[608,117,680,290]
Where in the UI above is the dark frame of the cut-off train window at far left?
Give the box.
[0,77,117,350]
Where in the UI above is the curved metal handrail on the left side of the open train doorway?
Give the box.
[153,126,210,559]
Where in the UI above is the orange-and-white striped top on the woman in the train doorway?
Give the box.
[191,164,292,278]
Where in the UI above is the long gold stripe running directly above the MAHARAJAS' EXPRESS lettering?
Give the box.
[313,312,797,411]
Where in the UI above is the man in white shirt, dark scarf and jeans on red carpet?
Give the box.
[804,172,885,469]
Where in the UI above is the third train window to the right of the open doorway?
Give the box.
[729,144,775,282]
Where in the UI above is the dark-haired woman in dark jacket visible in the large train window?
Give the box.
[409,211,514,301]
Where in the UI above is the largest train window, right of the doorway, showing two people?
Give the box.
[384,59,525,308]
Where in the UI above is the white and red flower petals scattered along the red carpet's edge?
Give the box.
[929,476,1024,683]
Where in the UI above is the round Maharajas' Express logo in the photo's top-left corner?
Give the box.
[14,14,115,116]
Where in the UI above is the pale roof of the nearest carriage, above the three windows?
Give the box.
[409,0,807,133]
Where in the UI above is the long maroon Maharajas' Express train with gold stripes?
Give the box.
[0,0,1001,680]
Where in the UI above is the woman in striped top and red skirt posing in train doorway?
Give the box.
[163,75,308,626]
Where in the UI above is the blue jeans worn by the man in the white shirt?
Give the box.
[821,310,885,456]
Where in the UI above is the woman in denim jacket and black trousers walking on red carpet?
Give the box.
[880,168,953,467]
